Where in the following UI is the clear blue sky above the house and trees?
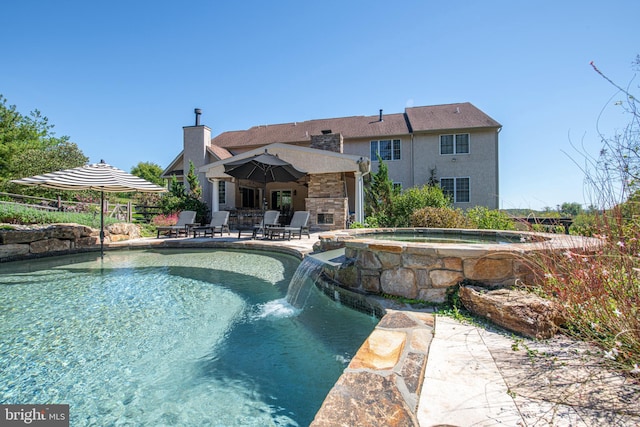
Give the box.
[0,0,640,209]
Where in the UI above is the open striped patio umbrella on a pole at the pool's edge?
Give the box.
[11,160,167,257]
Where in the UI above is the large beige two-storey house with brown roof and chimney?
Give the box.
[163,102,502,229]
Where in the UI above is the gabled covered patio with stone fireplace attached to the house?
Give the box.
[199,143,370,230]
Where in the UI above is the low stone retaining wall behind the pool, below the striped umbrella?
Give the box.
[0,223,140,262]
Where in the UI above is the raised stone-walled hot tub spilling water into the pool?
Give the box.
[320,228,599,302]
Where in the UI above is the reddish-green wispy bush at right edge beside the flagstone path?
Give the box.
[533,209,640,372]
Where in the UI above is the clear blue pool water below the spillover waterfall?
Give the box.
[0,250,376,426]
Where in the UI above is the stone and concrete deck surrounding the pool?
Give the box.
[107,233,640,427]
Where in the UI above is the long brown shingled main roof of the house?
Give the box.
[211,102,501,150]
